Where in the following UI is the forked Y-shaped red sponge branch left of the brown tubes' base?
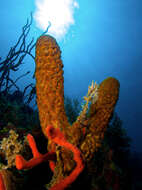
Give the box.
[15,134,56,170]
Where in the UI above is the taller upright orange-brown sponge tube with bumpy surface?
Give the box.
[35,35,68,136]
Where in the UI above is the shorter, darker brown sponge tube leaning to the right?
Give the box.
[80,77,120,161]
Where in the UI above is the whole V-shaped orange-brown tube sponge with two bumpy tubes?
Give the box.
[35,35,120,171]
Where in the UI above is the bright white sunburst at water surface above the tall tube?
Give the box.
[34,0,79,39]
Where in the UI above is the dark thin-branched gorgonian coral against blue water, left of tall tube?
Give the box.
[0,13,36,92]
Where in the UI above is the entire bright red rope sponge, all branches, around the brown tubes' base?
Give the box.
[15,126,84,190]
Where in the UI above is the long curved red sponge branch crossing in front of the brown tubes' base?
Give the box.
[46,126,84,190]
